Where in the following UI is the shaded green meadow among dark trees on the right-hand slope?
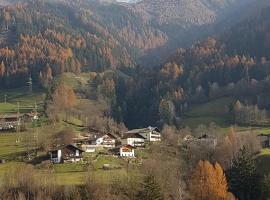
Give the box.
[183,98,234,128]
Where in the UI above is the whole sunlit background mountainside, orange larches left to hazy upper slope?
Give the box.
[0,0,260,87]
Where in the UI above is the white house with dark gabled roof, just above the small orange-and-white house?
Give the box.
[121,133,145,147]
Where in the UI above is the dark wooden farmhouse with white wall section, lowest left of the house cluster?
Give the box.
[50,144,84,163]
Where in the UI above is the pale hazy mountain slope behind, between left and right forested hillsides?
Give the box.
[117,0,254,66]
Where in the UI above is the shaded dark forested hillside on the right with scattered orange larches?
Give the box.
[116,2,270,127]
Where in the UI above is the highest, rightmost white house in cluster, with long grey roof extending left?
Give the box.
[126,126,161,142]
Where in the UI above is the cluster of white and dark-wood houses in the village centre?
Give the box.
[50,126,161,163]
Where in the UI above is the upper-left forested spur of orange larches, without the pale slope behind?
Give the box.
[0,1,166,87]
